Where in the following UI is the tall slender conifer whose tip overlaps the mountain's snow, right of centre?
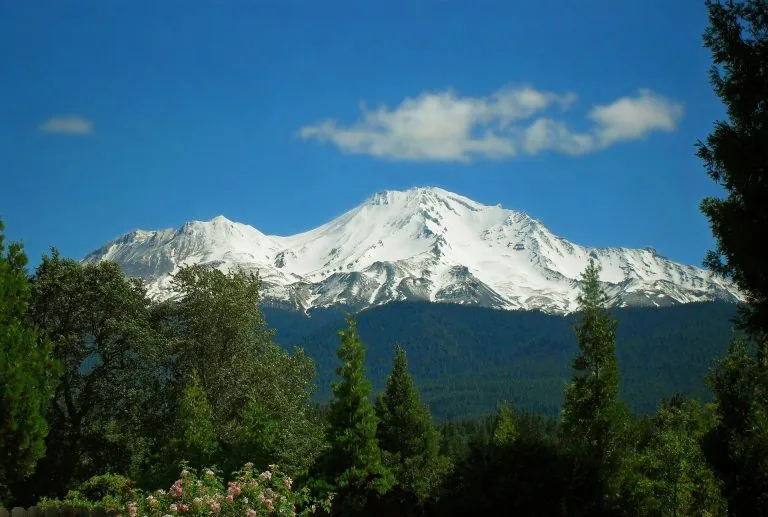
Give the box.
[560,260,629,515]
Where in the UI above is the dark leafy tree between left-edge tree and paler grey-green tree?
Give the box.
[25,250,169,499]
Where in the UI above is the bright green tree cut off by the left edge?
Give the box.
[0,220,58,508]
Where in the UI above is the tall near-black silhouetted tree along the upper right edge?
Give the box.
[697,0,768,332]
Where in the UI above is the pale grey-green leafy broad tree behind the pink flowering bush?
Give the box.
[168,266,323,474]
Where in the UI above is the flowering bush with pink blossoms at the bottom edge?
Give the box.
[127,463,331,517]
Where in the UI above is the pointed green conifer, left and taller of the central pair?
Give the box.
[322,316,394,515]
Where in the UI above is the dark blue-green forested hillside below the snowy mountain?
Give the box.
[264,302,736,419]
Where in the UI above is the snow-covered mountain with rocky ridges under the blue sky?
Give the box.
[84,188,743,313]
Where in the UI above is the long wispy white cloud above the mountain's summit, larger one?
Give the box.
[299,86,683,162]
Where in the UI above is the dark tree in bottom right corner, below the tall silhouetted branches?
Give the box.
[708,337,768,517]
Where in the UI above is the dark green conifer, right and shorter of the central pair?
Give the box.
[376,344,449,503]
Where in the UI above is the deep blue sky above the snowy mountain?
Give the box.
[0,0,723,264]
